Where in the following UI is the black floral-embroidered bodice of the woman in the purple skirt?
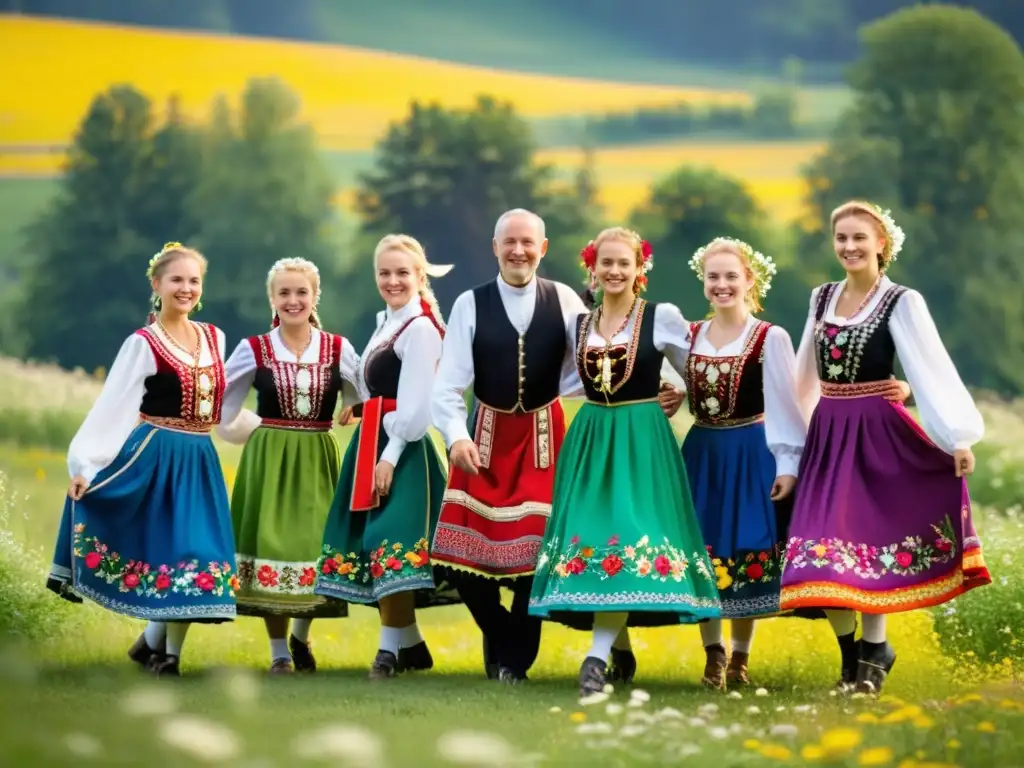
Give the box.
[814,283,906,384]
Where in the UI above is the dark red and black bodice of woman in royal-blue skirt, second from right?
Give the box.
[686,321,772,425]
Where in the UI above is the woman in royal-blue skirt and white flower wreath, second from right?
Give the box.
[682,238,905,688]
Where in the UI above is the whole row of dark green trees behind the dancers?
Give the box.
[8,6,1024,394]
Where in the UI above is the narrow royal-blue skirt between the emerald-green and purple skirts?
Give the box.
[682,422,793,618]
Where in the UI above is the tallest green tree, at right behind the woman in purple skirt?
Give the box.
[801,5,1024,393]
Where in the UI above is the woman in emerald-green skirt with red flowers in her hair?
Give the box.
[529,227,720,696]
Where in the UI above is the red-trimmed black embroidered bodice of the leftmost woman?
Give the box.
[136,323,224,427]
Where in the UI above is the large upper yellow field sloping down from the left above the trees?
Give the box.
[0,16,751,150]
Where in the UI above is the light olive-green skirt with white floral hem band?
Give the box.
[231,426,348,618]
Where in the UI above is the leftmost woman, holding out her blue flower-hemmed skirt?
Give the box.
[47,243,238,675]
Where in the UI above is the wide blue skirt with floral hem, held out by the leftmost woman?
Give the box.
[47,423,238,623]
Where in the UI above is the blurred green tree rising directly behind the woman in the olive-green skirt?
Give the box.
[188,80,339,339]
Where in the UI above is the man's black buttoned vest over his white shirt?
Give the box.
[473,278,565,412]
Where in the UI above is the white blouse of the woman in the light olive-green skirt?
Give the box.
[217,327,361,445]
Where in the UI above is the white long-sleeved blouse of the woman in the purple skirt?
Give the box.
[797,278,985,454]
